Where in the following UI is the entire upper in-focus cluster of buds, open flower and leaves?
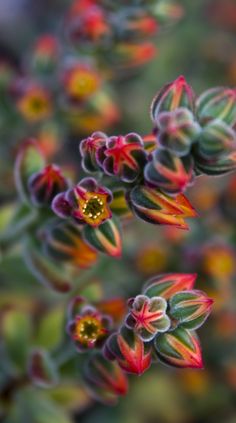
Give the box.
[1,77,236,292]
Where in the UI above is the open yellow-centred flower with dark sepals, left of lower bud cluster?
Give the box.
[67,297,112,352]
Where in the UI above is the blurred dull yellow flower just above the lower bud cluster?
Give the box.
[136,245,168,275]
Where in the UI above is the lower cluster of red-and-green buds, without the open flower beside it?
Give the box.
[104,273,213,374]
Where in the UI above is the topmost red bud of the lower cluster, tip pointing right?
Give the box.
[143,273,197,300]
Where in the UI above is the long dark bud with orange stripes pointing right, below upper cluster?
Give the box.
[128,185,197,229]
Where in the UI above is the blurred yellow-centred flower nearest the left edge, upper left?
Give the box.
[17,86,52,122]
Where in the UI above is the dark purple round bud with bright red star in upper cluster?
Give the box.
[97,133,147,182]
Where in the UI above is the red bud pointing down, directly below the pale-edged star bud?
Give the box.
[105,326,152,375]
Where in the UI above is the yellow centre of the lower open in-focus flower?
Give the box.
[74,316,103,344]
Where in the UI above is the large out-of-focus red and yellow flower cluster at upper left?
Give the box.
[0,0,182,196]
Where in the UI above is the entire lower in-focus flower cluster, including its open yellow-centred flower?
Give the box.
[65,273,213,403]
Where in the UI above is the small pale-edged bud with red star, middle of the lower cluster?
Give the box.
[126,295,170,342]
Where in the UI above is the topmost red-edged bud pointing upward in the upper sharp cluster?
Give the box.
[151,76,195,122]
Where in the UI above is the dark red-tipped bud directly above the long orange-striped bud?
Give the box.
[144,149,193,194]
